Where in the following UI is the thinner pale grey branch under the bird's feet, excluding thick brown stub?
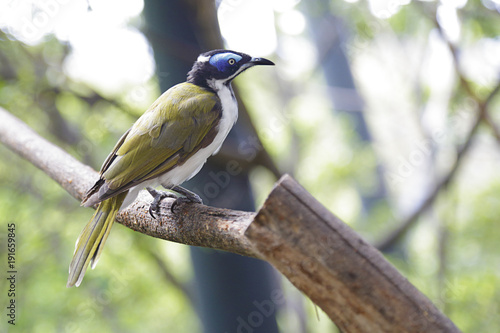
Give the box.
[0,108,255,257]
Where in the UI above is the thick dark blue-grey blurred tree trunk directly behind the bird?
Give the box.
[144,0,278,333]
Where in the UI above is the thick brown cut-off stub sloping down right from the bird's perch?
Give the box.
[245,176,458,332]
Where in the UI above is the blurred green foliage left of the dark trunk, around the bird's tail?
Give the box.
[0,35,199,332]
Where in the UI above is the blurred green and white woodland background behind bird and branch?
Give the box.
[0,0,500,333]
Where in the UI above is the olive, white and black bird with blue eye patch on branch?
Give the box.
[67,49,274,288]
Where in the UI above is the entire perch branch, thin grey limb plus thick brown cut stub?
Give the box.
[0,108,459,332]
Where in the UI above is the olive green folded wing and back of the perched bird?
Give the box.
[89,83,222,201]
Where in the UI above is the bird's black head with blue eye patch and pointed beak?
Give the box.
[187,50,274,90]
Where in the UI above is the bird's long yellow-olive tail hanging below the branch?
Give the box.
[66,191,128,288]
